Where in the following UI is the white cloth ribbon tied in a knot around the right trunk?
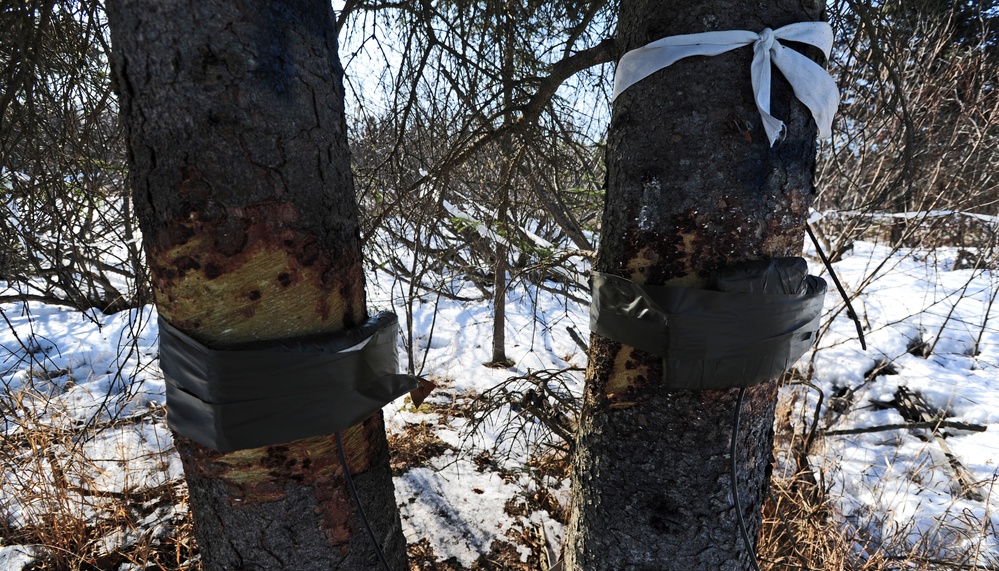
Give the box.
[613,22,839,146]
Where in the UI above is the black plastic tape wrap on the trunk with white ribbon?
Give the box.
[590,258,826,389]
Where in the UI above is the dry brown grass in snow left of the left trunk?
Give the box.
[0,382,200,571]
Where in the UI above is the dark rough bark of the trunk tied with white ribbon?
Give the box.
[566,0,822,571]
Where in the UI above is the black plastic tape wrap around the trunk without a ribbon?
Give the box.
[159,312,420,452]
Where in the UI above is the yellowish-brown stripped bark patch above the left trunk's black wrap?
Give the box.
[148,199,363,343]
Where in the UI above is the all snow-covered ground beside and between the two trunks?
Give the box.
[0,242,999,570]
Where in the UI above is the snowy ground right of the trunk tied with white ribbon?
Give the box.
[799,243,999,566]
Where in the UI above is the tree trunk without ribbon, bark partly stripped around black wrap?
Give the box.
[107,0,406,571]
